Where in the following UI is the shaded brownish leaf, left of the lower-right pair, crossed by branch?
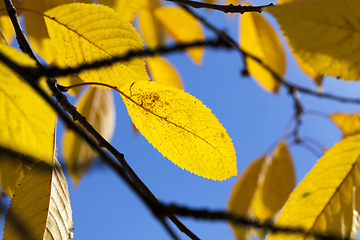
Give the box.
[228,156,266,240]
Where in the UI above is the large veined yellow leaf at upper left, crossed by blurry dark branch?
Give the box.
[45,3,148,88]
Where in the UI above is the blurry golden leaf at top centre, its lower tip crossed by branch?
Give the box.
[155,7,204,64]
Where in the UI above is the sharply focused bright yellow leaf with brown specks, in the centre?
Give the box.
[121,81,237,180]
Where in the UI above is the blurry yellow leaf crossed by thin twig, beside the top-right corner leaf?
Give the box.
[239,13,286,93]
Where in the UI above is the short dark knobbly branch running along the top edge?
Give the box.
[166,0,274,14]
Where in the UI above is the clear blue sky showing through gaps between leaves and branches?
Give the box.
[3,1,360,240]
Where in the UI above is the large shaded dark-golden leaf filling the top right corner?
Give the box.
[264,0,360,80]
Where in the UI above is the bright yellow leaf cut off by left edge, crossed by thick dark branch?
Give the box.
[0,44,56,159]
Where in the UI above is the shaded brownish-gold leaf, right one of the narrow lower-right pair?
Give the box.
[252,142,295,220]
